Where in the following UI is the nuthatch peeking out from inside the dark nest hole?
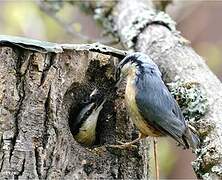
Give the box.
[72,88,106,146]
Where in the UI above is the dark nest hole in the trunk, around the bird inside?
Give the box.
[64,60,116,146]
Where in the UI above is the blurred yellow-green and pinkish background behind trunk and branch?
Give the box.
[0,0,222,179]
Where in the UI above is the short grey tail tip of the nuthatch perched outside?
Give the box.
[183,128,200,150]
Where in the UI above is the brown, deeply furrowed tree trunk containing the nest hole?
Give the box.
[0,37,148,179]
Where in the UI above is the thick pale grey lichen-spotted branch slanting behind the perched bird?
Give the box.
[80,0,222,179]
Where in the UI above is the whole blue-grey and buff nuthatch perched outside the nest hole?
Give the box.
[116,53,199,149]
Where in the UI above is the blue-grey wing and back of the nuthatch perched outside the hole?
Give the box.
[136,72,187,144]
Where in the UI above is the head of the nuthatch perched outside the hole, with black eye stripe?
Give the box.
[115,52,161,81]
